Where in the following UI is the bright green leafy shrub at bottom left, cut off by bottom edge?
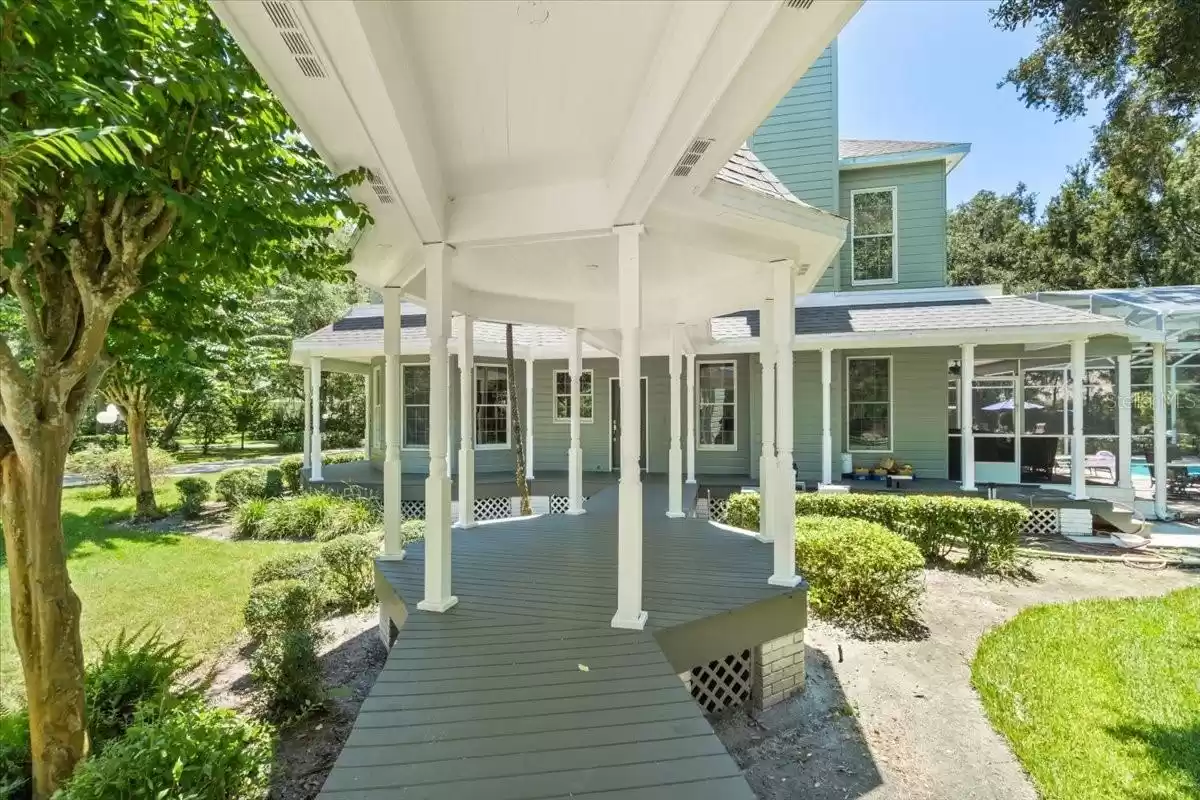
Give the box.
[55,699,272,800]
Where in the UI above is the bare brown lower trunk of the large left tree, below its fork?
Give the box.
[0,435,88,798]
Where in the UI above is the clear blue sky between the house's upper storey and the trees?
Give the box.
[838,0,1098,207]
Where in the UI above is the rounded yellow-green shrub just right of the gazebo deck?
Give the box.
[796,517,925,634]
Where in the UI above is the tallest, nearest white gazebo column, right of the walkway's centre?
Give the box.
[612,225,646,630]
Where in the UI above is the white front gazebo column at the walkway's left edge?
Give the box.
[416,242,458,612]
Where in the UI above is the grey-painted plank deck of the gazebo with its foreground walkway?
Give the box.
[322,479,804,800]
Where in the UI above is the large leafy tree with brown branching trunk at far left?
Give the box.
[0,0,365,798]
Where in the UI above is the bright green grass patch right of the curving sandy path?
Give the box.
[972,588,1200,800]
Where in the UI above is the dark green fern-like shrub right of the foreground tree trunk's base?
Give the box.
[84,631,193,752]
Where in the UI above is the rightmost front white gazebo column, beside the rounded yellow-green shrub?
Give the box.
[760,261,800,587]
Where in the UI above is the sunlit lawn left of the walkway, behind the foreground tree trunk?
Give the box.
[0,475,312,706]
